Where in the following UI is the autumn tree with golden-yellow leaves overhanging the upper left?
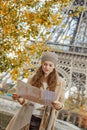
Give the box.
[0,0,72,80]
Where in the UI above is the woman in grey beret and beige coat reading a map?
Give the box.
[6,52,65,130]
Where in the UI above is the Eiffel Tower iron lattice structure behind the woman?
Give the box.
[47,0,87,105]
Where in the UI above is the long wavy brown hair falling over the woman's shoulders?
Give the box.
[30,66,60,91]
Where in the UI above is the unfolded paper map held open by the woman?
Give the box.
[16,80,56,106]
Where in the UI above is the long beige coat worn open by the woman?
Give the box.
[6,78,65,130]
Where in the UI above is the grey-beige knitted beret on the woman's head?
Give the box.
[41,52,58,65]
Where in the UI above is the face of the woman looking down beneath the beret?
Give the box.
[42,61,55,76]
